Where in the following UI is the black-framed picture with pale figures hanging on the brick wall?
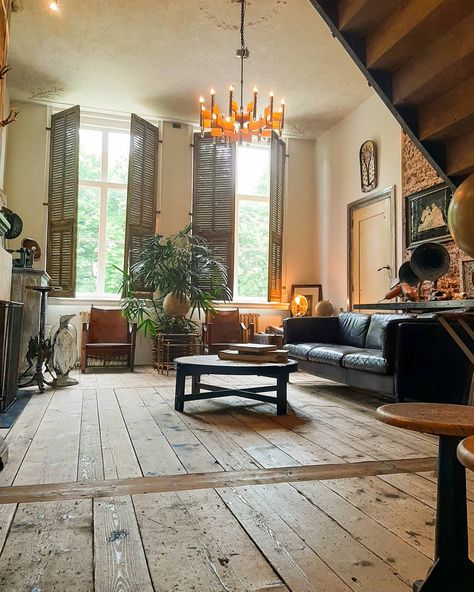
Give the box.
[405,184,452,249]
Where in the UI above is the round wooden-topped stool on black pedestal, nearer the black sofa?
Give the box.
[376,403,474,592]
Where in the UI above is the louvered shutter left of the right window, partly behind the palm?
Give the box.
[193,133,235,298]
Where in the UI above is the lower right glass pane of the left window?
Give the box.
[105,189,127,294]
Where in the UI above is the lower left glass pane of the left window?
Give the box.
[76,187,100,293]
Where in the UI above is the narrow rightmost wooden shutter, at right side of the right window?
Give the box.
[268,132,286,302]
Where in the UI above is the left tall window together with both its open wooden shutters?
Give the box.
[46,105,160,298]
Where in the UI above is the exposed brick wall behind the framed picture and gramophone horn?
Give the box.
[402,133,470,292]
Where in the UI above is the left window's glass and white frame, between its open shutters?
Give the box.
[76,124,130,296]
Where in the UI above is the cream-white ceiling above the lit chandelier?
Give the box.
[8,0,371,137]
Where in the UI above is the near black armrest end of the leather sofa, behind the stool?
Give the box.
[395,318,473,404]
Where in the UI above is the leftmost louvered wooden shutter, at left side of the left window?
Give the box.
[46,105,80,297]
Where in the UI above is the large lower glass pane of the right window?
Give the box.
[237,199,270,299]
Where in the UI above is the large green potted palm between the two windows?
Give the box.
[122,225,230,366]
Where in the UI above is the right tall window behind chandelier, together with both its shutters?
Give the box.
[193,132,286,302]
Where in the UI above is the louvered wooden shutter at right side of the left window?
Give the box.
[124,113,159,293]
